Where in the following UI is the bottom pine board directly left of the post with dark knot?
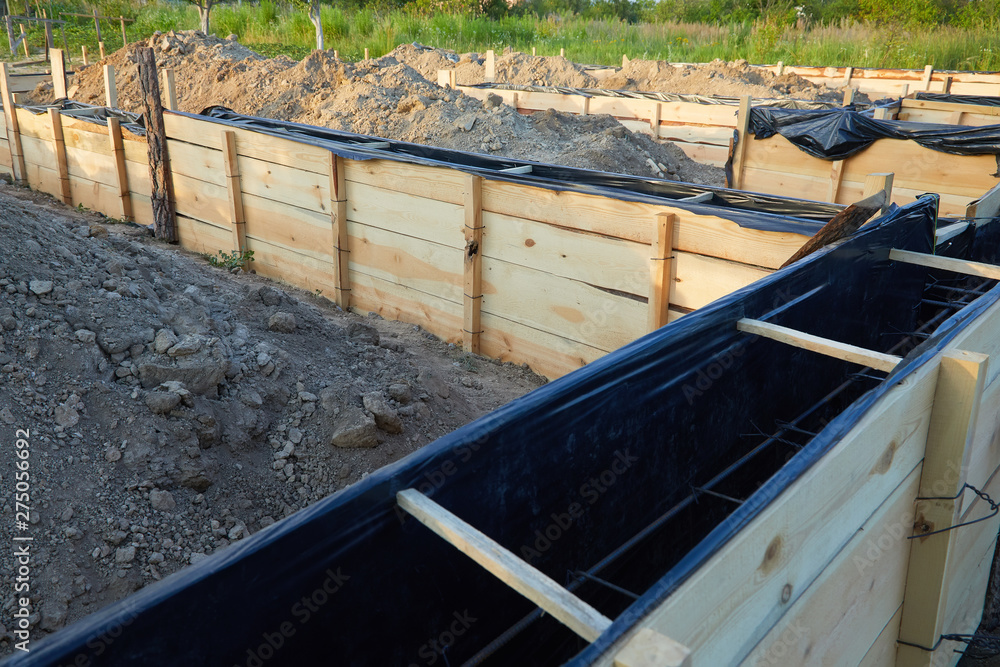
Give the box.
[351,265,462,344]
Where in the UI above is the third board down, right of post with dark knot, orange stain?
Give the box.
[482,257,646,352]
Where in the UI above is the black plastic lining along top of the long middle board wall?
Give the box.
[193,106,844,226]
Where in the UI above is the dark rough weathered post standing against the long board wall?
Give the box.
[136,47,177,243]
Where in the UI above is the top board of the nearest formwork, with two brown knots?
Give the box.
[598,363,937,665]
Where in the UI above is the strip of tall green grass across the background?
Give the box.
[0,0,1000,70]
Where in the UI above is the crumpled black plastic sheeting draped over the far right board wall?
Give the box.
[750,107,1000,160]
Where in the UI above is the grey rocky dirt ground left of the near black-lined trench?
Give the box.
[0,184,542,653]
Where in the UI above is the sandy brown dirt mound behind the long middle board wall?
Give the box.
[38,32,723,185]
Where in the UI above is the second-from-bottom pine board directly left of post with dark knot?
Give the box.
[348,222,464,308]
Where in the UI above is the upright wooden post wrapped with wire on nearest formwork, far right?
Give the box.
[896,350,989,666]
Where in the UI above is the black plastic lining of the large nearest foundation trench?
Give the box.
[8,196,997,667]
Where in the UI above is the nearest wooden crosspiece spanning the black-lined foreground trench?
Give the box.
[396,489,611,642]
